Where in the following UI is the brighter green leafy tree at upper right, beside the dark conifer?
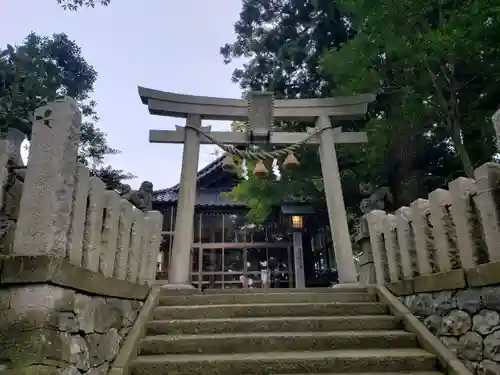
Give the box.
[323,0,500,181]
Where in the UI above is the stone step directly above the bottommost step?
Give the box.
[139,331,417,355]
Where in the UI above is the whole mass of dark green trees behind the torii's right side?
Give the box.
[225,0,500,226]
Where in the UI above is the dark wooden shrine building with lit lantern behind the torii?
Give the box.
[153,157,336,289]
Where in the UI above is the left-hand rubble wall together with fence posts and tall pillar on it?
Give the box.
[0,98,163,375]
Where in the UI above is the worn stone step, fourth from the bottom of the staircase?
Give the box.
[153,302,388,320]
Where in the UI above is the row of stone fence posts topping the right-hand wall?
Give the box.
[358,163,500,291]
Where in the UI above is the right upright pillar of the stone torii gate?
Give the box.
[316,116,358,284]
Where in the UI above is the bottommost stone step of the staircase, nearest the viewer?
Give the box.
[131,349,436,375]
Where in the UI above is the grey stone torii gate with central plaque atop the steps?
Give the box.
[139,87,375,288]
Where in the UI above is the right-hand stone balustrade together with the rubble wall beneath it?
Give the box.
[358,163,500,374]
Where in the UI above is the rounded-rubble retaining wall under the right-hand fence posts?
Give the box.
[399,286,500,375]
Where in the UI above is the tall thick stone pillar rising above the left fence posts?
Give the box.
[13,97,81,257]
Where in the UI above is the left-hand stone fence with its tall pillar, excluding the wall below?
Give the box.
[0,99,163,284]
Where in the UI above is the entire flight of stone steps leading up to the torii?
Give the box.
[131,288,441,375]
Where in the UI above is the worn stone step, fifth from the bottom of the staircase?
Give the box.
[159,293,377,306]
